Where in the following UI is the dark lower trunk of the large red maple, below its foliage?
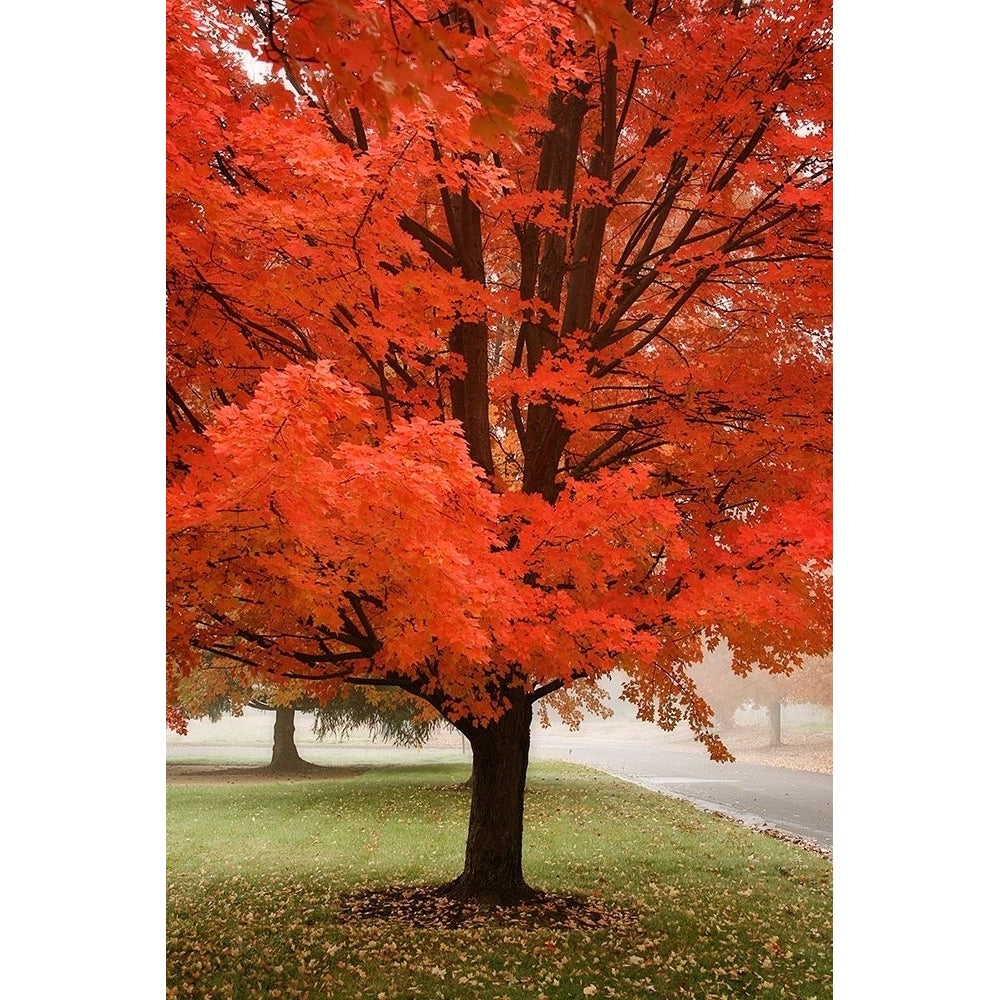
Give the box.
[443,692,535,904]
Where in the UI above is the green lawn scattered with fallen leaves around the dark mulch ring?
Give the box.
[167,764,832,1000]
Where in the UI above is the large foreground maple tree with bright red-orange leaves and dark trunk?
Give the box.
[167,0,832,900]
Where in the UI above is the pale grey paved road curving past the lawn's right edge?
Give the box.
[532,731,833,853]
